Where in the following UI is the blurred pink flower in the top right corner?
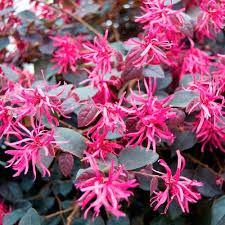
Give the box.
[196,0,225,41]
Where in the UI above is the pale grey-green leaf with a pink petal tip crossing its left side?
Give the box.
[54,127,86,158]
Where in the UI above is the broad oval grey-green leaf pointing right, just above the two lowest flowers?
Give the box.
[119,146,159,170]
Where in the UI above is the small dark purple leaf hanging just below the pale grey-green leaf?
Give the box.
[59,153,74,177]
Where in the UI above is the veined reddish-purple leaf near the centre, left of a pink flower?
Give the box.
[77,104,100,127]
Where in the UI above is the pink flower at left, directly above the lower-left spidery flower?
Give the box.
[11,81,66,126]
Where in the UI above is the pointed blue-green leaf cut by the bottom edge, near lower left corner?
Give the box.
[19,208,41,225]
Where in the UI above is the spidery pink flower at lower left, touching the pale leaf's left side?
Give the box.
[5,123,59,180]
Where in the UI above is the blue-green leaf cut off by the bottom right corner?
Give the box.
[211,195,225,225]
